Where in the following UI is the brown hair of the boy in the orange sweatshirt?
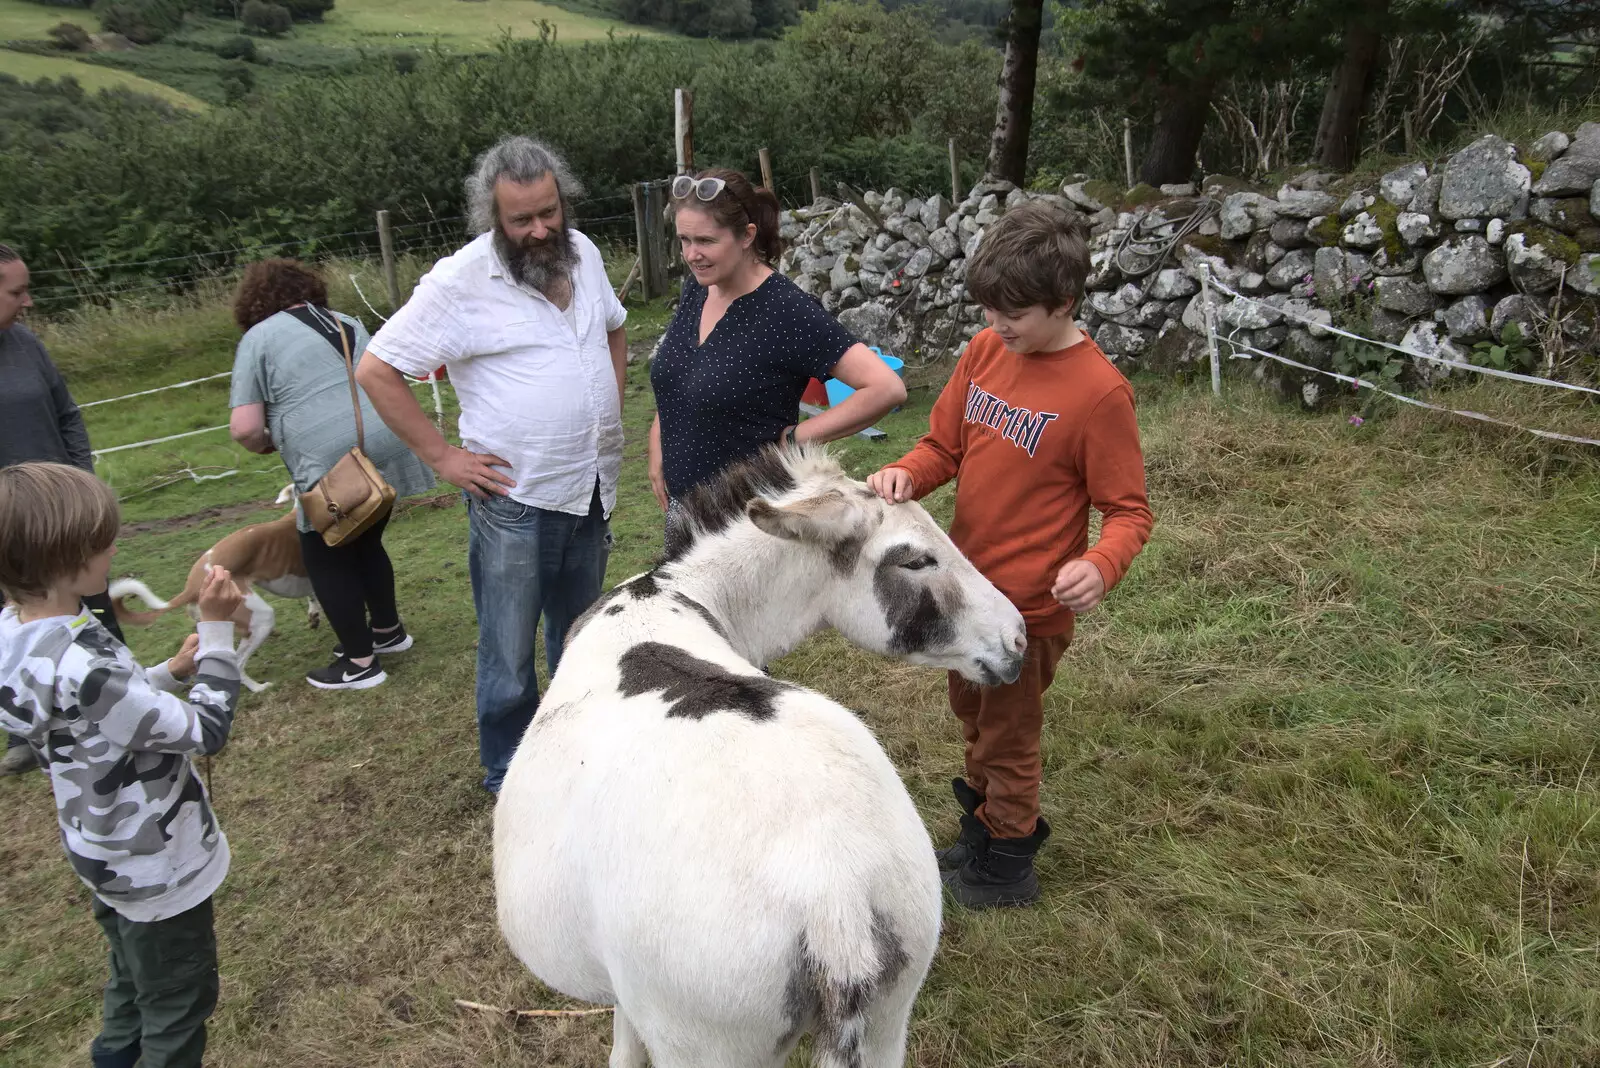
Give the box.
[966,200,1090,315]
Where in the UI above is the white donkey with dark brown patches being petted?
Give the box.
[494,448,1026,1068]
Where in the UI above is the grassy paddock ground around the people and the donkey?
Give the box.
[0,271,1600,1068]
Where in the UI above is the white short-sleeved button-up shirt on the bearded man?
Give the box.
[366,230,627,516]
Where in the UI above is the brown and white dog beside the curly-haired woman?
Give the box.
[110,484,322,692]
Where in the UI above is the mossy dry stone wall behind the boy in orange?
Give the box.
[781,123,1600,404]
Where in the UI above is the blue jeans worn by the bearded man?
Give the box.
[467,484,611,793]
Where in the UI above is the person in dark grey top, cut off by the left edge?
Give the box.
[0,245,122,775]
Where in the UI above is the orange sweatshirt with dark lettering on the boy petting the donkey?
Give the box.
[893,329,1155,636]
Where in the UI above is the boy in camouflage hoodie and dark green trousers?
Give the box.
[0,464,243,1068]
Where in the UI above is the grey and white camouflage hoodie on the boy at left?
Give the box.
[0,606,238,923]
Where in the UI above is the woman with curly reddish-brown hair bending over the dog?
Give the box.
[229,259,434,689]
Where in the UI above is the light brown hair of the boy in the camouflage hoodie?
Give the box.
[0,464,122,601]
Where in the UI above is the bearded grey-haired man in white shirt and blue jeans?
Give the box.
[357,137,627,795]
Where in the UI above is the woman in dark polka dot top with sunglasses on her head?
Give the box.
[650,169,906,553]
